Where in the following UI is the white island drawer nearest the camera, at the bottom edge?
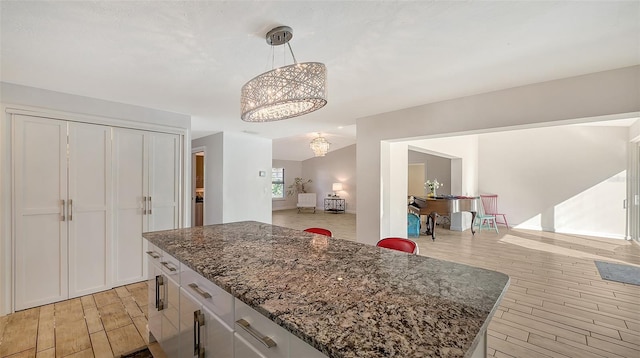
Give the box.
[234,299,290,358]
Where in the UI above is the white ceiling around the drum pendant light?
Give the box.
[0,1,640,160]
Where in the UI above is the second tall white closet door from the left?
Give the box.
[68,123,112,297]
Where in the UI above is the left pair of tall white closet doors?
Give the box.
[13,115,112,310]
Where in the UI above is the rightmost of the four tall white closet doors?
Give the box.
[146,133,180,231]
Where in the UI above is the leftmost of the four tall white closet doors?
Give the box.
[13,115,68,310]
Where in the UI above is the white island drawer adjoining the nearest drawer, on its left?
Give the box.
[180,265,234,329]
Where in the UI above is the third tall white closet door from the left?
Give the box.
[113,128,147,286]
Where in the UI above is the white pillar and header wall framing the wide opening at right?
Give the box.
[356,66,640,244]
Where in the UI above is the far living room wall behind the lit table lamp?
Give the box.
[302,144,358,213]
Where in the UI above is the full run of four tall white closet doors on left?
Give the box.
[12,114,182,310]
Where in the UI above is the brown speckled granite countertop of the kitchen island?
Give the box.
[143,222,509,358]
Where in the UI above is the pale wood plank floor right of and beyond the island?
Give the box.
[273,210,640,358]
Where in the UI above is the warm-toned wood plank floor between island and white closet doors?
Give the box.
[0,282,164,358]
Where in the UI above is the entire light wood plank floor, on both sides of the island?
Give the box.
[0,210,640,358]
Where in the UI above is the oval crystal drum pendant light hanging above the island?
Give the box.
[240,26,327,122]
